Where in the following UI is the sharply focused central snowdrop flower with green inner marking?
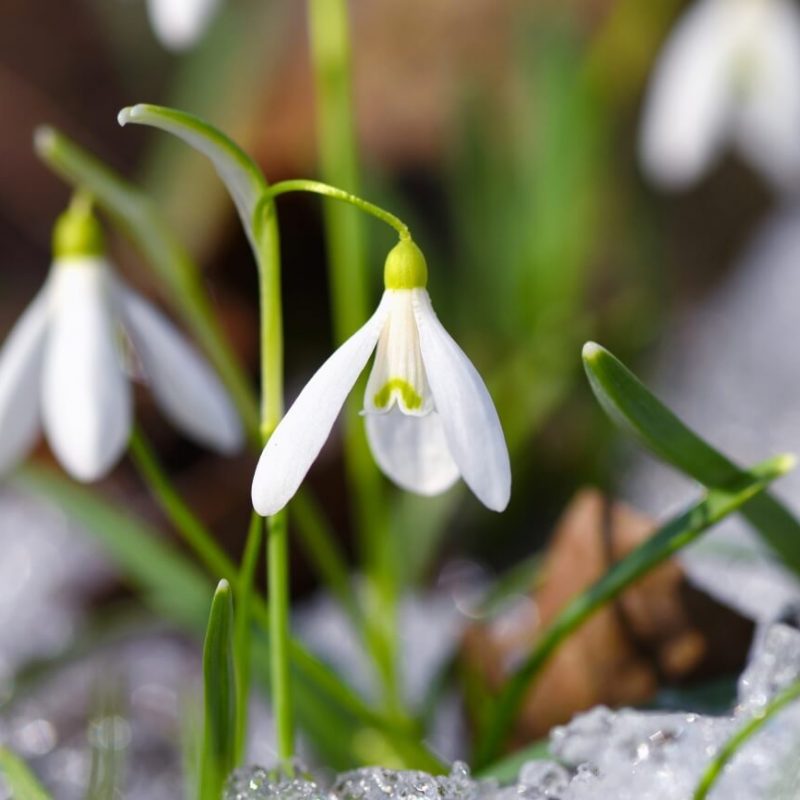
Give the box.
[252,239,511,516]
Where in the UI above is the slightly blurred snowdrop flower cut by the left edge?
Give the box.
[0,201,243,481]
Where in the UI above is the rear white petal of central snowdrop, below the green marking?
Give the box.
[365,406,459,496]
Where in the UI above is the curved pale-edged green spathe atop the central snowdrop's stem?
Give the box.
[118,103,268,254]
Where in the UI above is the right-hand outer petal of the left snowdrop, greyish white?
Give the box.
[115,279,243,453]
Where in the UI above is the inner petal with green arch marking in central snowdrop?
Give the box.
[364,289,433,416]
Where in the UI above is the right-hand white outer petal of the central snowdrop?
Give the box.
[414,289,511,511]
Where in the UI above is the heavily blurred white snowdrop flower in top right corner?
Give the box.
[640,0,800,189]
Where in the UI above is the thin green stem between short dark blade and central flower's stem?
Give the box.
[234,512,264,764]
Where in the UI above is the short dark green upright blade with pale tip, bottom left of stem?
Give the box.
[198,580,237,800]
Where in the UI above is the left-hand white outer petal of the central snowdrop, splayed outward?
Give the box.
[252,294,390,517]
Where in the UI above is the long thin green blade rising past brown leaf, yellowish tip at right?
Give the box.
[475,455,795,768]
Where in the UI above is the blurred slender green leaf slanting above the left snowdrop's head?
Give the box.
[34,127,260,442]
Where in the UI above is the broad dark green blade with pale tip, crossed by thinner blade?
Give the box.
[583,342,800,573]
